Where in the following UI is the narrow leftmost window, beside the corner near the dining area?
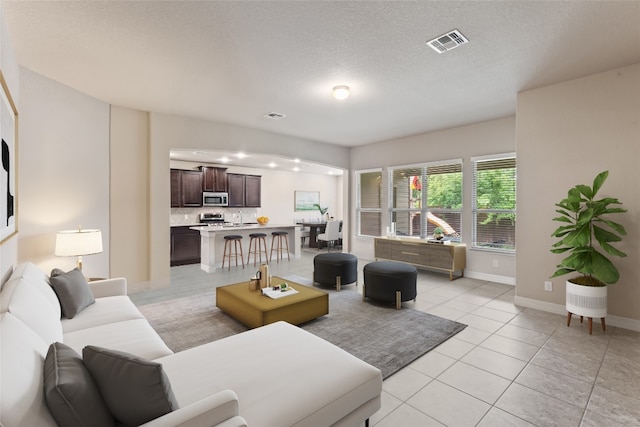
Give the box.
[356,169,382,236]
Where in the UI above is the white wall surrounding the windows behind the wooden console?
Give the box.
[350,117,516,284]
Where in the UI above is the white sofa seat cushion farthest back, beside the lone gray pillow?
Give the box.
[61,296,144,334]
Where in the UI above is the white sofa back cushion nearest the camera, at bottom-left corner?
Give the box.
[0,313,57,427]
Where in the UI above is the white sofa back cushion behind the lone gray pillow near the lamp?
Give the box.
[0,277,62,344]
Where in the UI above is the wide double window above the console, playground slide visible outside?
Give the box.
[389,160,462,241]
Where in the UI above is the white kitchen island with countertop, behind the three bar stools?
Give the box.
[191,224,301,273]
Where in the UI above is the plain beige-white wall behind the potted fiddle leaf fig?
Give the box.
[516,64,640,328]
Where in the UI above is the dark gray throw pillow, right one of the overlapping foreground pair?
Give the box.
[82,345,178,426]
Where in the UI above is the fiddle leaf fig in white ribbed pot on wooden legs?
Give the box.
[551,171,627,333]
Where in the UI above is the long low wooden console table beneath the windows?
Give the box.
[374,237,467,280]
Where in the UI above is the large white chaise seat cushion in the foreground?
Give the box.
[157,322,382,426]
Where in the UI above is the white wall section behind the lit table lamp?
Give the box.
[18,68,110,277]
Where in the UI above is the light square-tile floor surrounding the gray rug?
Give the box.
[131,250,640,427]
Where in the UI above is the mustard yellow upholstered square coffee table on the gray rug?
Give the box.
[216,277,329,328]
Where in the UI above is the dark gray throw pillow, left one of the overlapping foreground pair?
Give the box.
[43,342,115,427]
